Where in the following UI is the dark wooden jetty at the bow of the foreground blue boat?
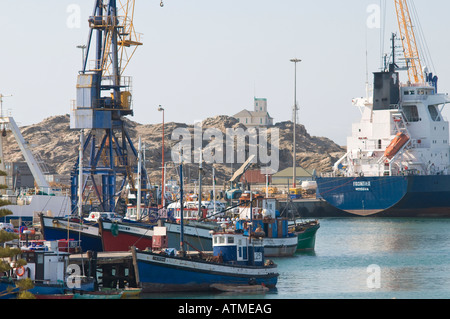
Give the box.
[69,251,137,288]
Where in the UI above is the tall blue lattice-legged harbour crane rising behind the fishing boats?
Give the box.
[70,0,148,213]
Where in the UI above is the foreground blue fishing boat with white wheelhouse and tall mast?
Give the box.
[132,165,278,292]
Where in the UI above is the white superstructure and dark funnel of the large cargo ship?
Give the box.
[334,64,450,176]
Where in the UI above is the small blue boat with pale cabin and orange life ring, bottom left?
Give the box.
[0,241,94,298]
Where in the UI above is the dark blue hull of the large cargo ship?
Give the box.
[316,175,450,217]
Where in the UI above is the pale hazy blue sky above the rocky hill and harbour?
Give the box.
[0,0,450,145]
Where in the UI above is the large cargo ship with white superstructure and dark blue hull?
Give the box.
[316,31,450,217]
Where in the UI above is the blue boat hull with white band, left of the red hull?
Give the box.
[41,215,103,252]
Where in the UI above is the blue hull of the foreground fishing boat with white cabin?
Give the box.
[132,249,278,292]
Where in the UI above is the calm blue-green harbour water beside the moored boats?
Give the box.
[141,218,450,299]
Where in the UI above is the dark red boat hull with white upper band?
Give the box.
[99,220,153,251]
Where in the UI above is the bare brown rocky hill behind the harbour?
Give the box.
[3,114,345,186]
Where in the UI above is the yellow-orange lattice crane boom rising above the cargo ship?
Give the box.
[395,0,425,83]
